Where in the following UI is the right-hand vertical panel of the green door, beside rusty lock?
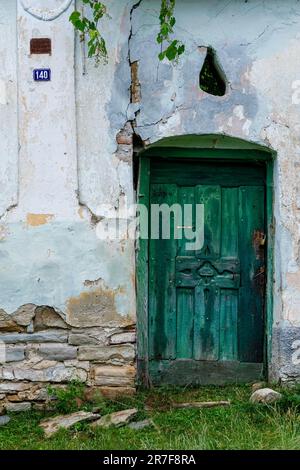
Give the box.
[238,186,265,362]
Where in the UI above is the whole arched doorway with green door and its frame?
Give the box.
[137,135,274,385]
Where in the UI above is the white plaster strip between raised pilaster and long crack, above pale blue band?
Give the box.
[76,1,134,215]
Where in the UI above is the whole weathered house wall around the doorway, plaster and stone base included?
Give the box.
[0,0,300,401]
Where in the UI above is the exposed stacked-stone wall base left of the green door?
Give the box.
[0,304,136,411]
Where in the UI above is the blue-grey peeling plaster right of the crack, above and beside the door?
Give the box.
[130,0,300,382]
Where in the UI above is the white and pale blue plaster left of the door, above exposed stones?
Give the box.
[0,0,135,322]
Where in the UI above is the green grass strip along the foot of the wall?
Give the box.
[0,386,300,450]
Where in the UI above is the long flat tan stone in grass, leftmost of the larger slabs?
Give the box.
[40,411,100,437]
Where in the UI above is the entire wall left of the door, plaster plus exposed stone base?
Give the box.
[0,0,136,409]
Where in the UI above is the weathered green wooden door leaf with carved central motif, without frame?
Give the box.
[148,159,266,385]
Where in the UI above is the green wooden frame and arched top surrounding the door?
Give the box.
[136,134,276,387]
